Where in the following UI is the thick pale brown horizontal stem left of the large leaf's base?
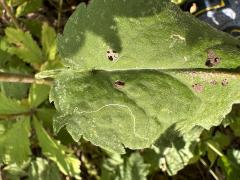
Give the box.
[0,72,53,85]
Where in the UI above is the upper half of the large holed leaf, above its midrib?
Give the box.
[58,0,240,71]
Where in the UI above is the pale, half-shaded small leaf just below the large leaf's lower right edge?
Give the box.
[154,127,202,176]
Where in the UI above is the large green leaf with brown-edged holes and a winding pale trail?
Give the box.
[50,0,240,153]
